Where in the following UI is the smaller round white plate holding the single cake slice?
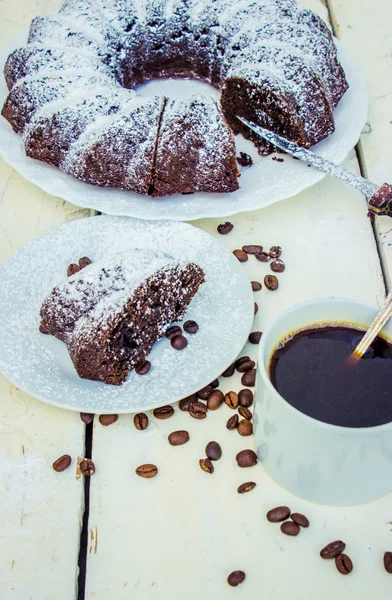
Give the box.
[0,216,253,413]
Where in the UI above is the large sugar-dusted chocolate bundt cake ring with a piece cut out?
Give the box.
[2,0,347,196]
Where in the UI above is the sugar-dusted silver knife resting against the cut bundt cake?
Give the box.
[237,117,392,217]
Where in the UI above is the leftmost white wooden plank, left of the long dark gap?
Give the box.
[0,0,88,600]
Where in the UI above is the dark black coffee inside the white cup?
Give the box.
[270,326,392,427]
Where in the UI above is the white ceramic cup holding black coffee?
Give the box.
[254,299,392,505]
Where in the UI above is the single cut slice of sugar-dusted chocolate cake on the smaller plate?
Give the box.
[40,249,204,385]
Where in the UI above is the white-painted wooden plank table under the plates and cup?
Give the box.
[0,0,392,600]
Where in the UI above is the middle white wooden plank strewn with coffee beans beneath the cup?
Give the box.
[86,153,390,600]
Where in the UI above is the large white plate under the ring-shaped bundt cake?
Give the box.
[0,34,368,221]
